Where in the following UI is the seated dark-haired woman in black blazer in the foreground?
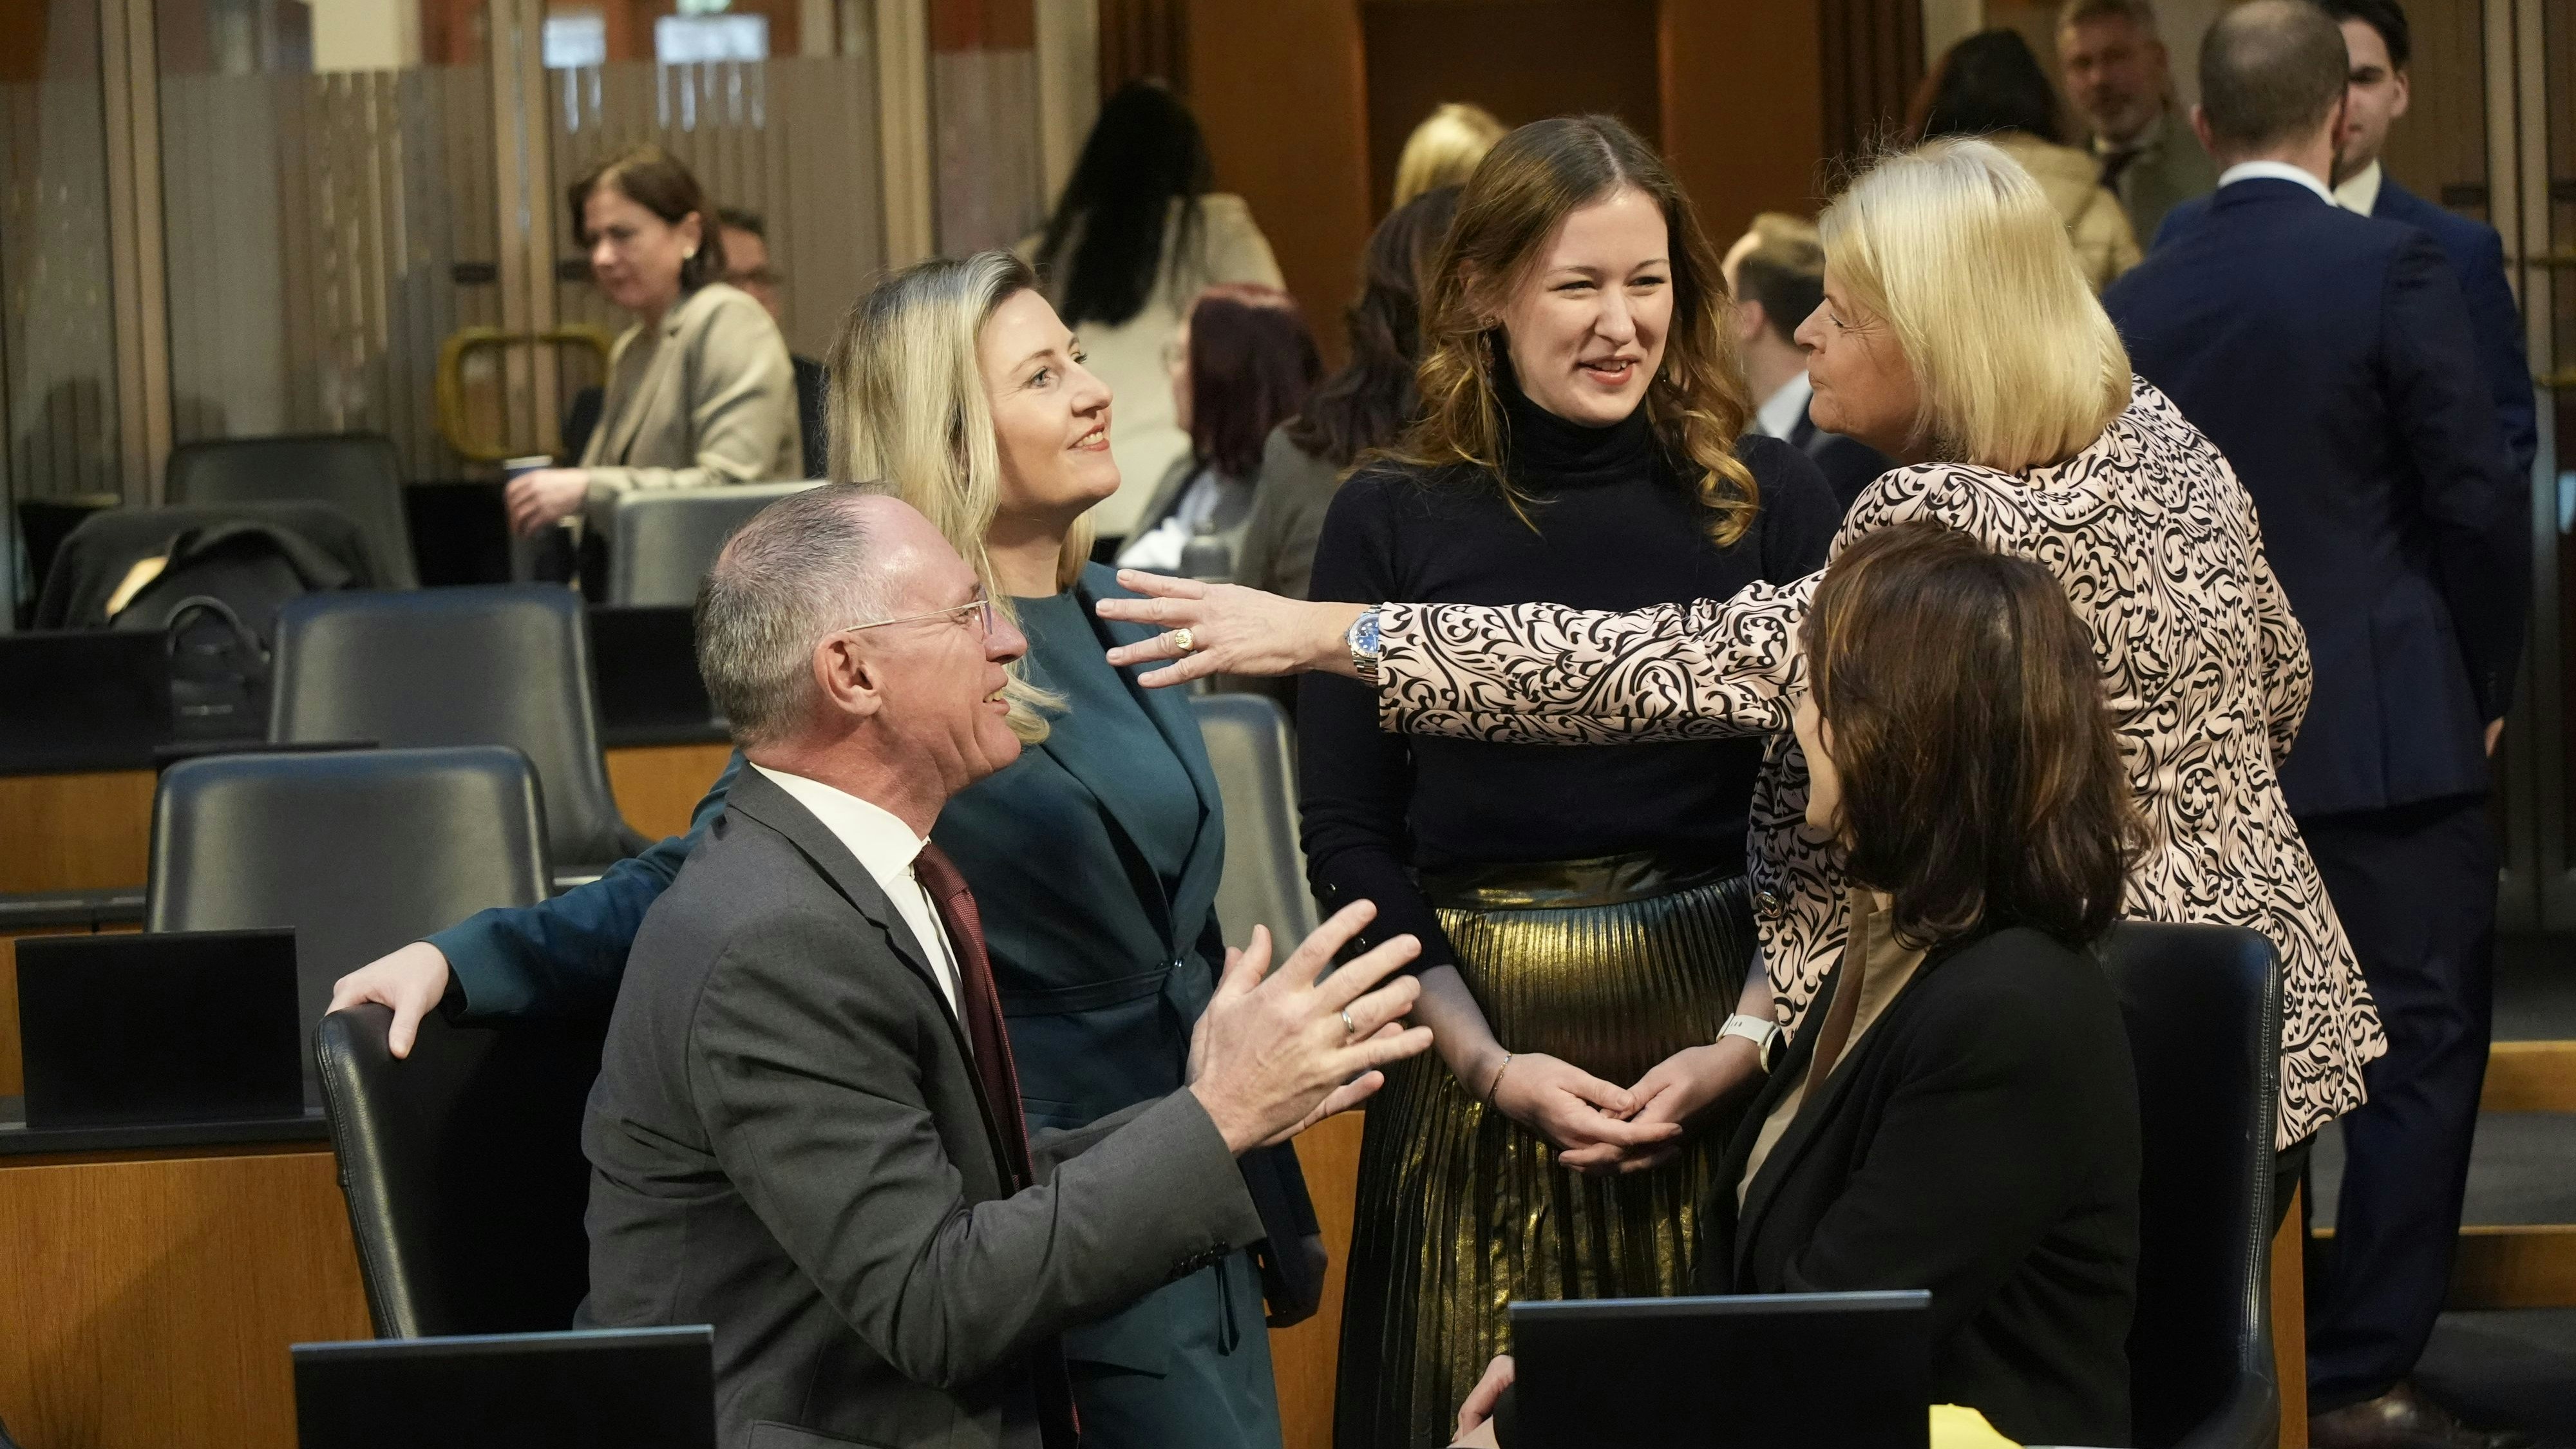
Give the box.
[1458,524,2143,1444]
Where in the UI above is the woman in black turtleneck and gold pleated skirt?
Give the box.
[1298,118,1839,1446]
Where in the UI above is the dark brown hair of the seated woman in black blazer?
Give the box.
[1806,524,2146,949]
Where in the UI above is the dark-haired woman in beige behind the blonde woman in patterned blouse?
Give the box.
[1906,31,2141,296]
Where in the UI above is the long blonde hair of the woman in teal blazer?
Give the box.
[827,252,1092,745]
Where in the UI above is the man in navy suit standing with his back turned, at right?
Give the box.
[2102,0,2530,1449]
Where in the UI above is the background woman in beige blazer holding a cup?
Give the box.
[507,147,806,536]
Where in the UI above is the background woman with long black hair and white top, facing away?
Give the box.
[1020,80,1280,539]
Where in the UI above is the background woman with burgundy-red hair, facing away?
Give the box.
[1118,286,1324,578]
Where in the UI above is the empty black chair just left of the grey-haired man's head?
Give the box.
[268,583,644,876]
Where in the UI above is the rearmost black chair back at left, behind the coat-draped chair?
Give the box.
[162,433,420,588]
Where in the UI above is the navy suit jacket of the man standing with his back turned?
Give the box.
[2102,178,2530,817]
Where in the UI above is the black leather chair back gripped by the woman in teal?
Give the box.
[314,1005,608,1338]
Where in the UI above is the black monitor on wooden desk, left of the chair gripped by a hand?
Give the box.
[18,931,304,1127]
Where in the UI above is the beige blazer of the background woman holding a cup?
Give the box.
[580,281,806,526]
